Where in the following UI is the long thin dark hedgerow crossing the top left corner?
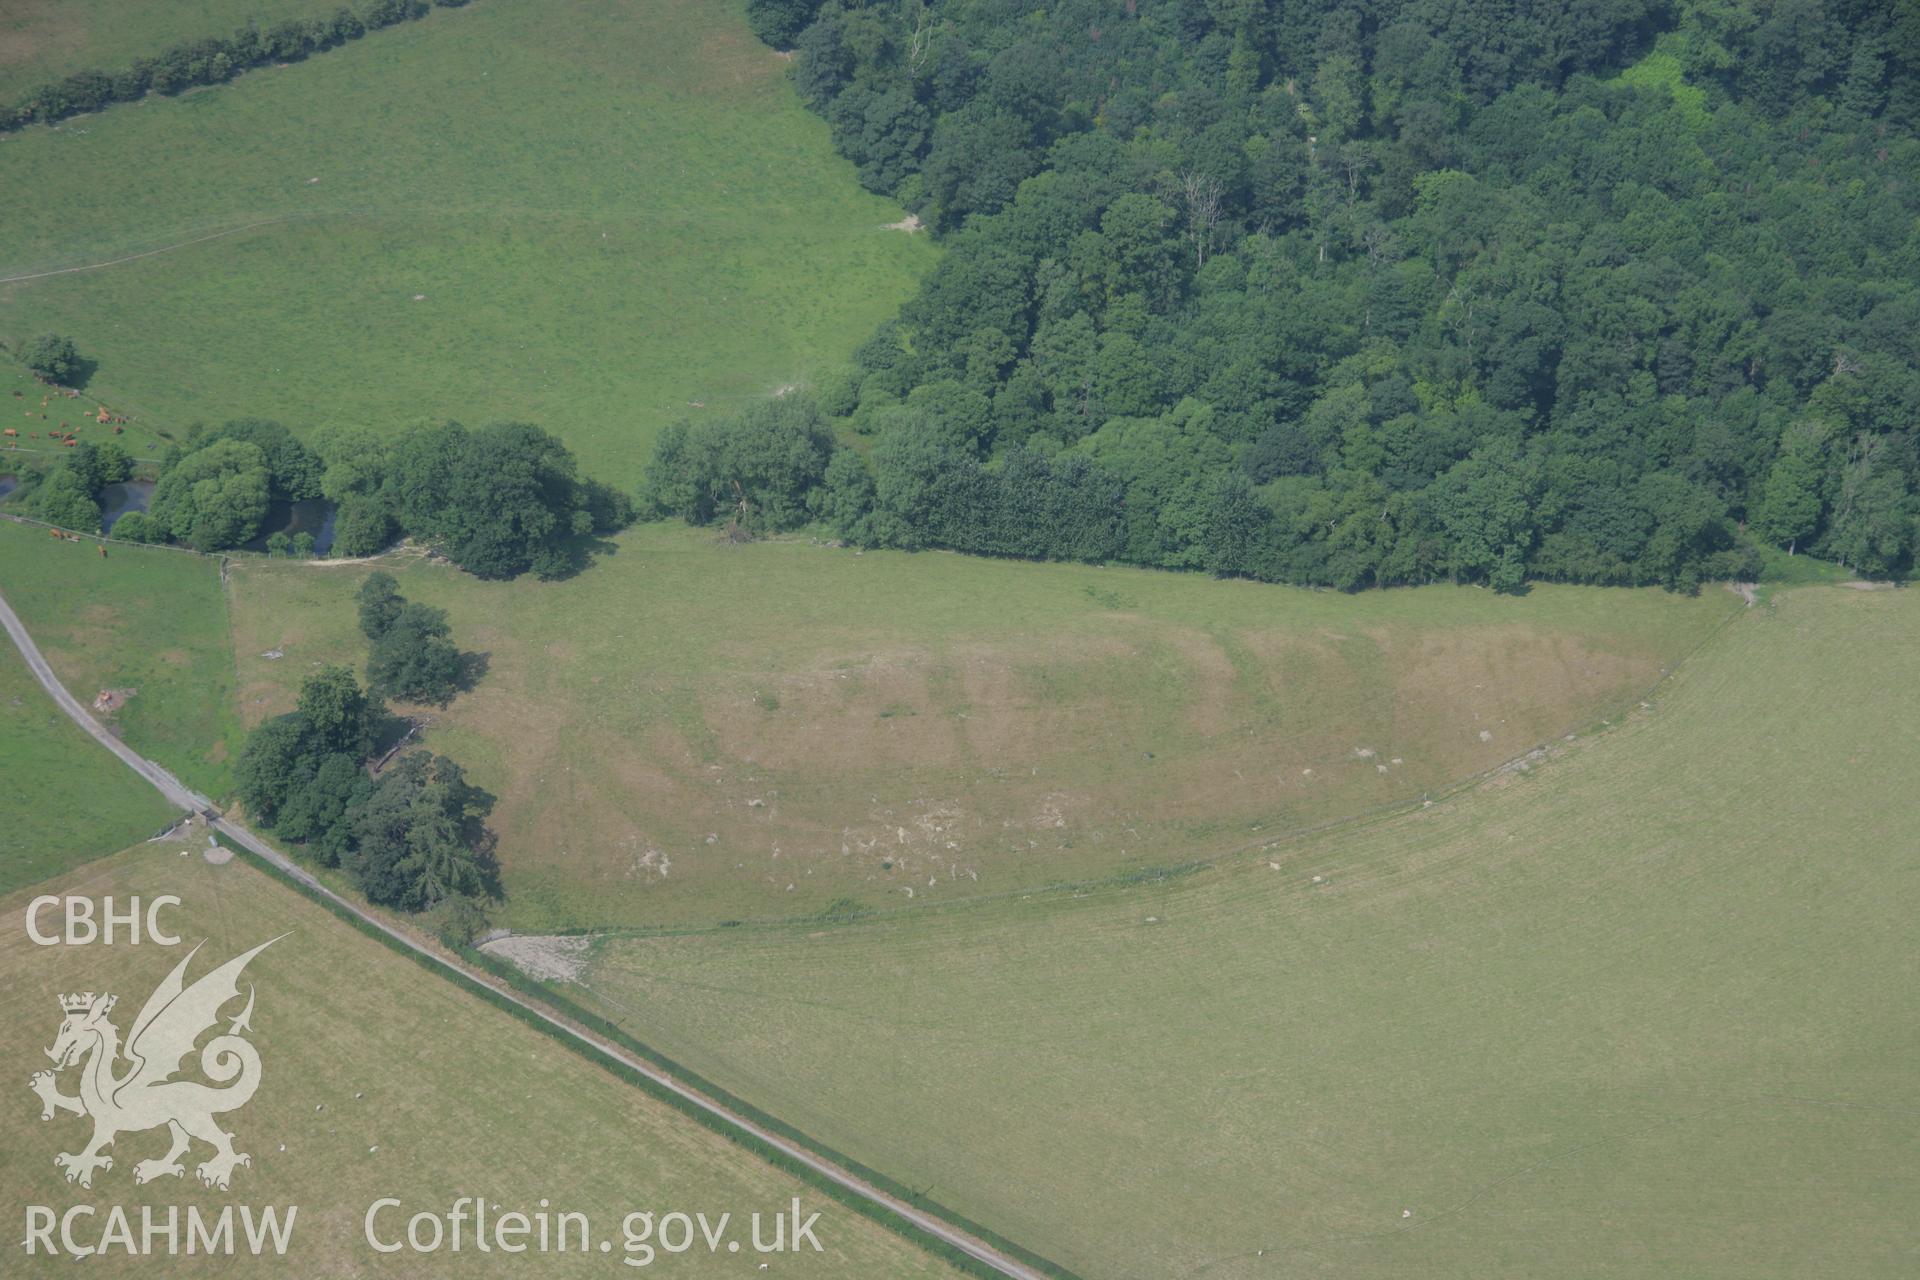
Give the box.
[0,0,467,129]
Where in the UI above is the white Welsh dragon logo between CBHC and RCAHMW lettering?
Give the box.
[29,935,286,1192]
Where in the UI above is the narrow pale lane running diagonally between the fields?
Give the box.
[0,595,1046,1280]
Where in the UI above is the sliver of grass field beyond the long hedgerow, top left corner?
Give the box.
[0,0,340,102]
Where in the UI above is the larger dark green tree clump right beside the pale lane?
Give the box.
[234,666,497,912]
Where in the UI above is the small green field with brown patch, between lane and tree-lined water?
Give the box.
[0,520,240,798]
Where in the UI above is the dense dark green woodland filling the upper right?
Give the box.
[660,0,1920,589]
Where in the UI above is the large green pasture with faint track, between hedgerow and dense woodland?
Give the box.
[0,0,933,486]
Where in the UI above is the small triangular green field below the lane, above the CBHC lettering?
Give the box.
[0,637,173,892]
